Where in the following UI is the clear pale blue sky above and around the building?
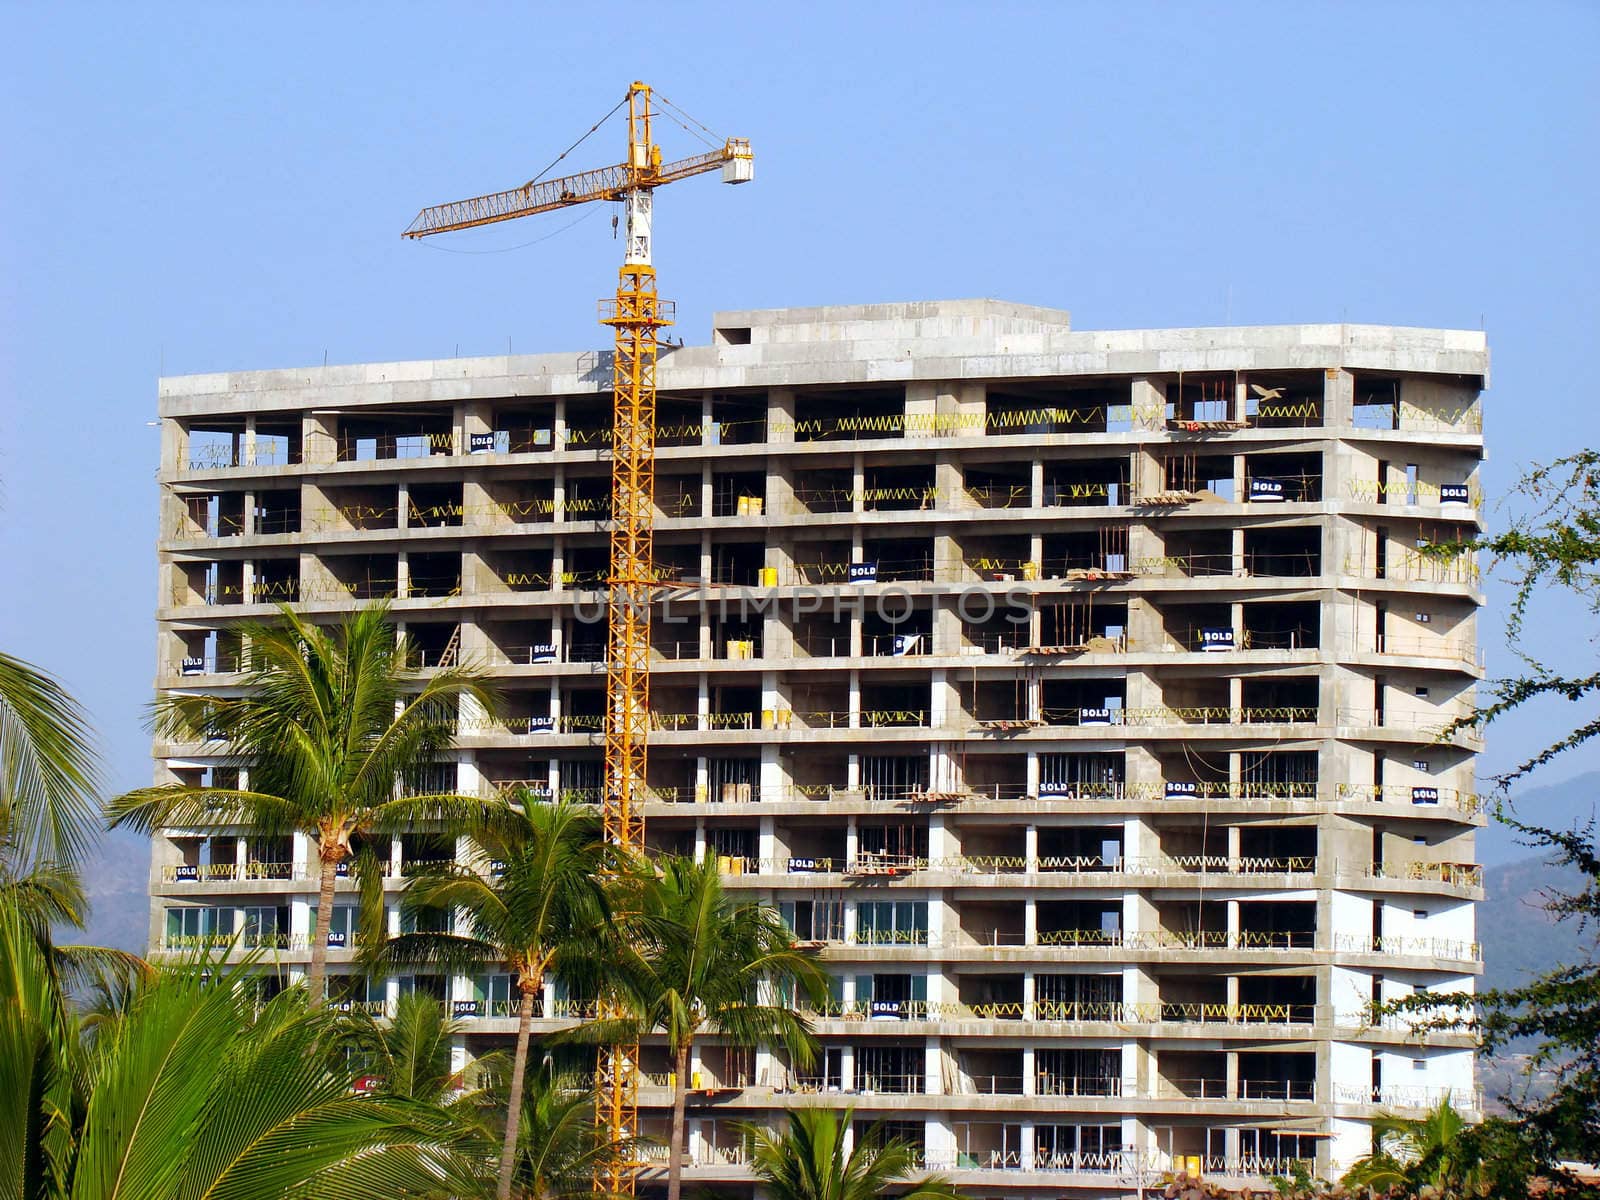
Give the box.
[0,0,1600,819]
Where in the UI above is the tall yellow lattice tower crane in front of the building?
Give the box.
[405,82,754,1195]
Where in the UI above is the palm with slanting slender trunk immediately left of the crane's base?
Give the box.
[381,800,611,1200]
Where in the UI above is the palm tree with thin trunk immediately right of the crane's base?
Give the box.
[618,856,827,1200]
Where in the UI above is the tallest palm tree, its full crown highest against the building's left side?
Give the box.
[107,603,504,1005]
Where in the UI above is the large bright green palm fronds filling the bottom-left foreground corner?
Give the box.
[0,904,488,1200]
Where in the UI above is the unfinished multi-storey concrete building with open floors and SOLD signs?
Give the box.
[150,301,1488,1197]
